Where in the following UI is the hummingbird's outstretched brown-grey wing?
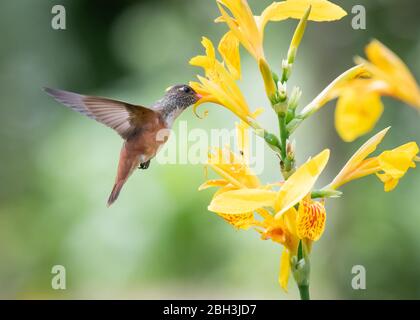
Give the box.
[44,88,156,139]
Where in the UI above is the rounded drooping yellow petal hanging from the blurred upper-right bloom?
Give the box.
[335,80,383,142]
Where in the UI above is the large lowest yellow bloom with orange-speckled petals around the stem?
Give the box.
[199,125,329,291]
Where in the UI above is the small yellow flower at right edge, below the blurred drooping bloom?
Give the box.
[329,128,419,191]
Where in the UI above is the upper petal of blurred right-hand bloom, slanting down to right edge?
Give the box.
[366,40,420,109]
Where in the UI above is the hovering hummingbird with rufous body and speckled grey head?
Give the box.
[44,84,201,207]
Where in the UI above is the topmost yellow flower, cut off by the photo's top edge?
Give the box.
[216,0,346,61]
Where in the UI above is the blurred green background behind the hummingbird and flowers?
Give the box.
[0,0,420,299]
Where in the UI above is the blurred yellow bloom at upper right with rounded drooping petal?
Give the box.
[302,40,420,142]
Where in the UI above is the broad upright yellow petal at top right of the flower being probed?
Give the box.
[218,31,241,79]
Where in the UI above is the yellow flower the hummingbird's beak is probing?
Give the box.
[190,37,252,122]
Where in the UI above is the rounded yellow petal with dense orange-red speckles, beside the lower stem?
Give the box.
[296,199,326,241]
